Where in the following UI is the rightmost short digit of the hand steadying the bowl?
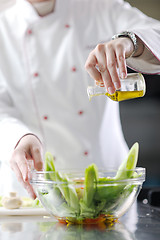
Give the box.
[30,144,43,171]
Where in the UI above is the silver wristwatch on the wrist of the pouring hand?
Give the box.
[112,31,138,57]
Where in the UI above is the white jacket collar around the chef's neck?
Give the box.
[16,0,60,24]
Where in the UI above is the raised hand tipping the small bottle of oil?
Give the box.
[85,37,144,94]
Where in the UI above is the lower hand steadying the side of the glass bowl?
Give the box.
[10,134,43,199]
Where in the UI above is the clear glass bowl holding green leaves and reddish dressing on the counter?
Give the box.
[30,168,145,224]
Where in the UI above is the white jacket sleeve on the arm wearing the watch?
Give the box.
[112,0,160,74]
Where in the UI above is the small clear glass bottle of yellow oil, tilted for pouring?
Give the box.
[87,73,146,102]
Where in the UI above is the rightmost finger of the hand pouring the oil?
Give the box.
[115,42,127,79]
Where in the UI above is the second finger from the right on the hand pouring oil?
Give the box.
[106,42,121,91]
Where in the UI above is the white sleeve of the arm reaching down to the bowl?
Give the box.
[0,78,31,162]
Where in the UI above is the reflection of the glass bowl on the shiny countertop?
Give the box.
[40,222,135,240]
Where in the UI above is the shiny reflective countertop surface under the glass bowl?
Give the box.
[0,203,160,240]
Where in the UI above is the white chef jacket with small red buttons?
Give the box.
[0,0,160,195]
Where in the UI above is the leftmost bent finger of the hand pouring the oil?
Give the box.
[85,51,103,82]
